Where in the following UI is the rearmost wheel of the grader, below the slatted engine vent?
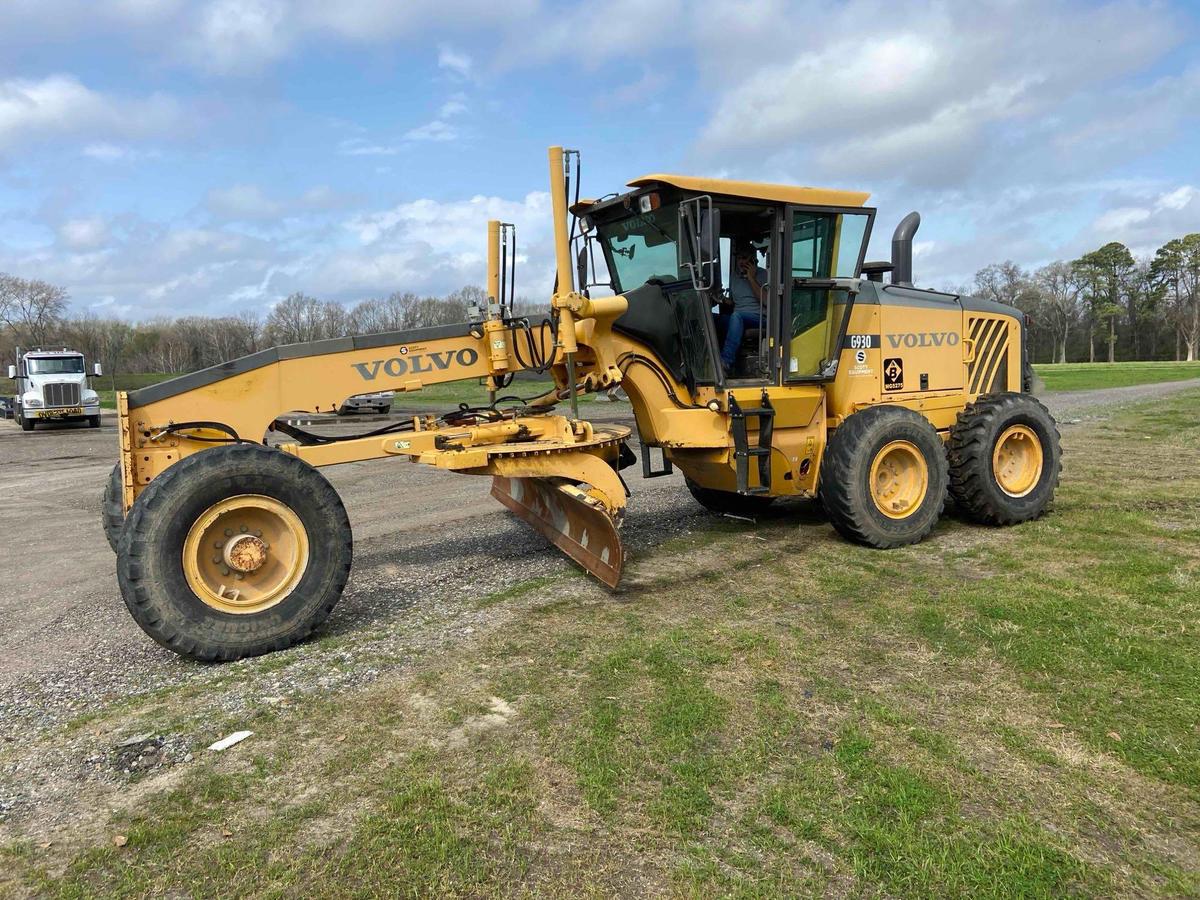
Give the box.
[948,394,1062,526]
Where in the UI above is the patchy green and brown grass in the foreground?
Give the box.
[11,391,1200,898]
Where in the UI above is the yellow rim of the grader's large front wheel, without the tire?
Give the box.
[184,494,308,614]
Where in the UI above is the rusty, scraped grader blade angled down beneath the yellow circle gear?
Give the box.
[492,475,625,588]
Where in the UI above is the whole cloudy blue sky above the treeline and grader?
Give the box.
[0,0,1200,319]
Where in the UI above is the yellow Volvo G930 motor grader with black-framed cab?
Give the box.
[104,146,1061,660]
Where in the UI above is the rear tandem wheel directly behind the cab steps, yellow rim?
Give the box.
[820,406,947,550]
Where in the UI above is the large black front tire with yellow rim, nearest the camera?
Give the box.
[116,444,353,660]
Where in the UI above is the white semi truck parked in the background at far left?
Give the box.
[8,348,101,431]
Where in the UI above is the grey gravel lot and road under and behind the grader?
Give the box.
[0,380,1200,839]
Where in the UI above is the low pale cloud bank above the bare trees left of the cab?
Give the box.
[0,185,553,318]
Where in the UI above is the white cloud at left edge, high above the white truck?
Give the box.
[0,74,180,151]
